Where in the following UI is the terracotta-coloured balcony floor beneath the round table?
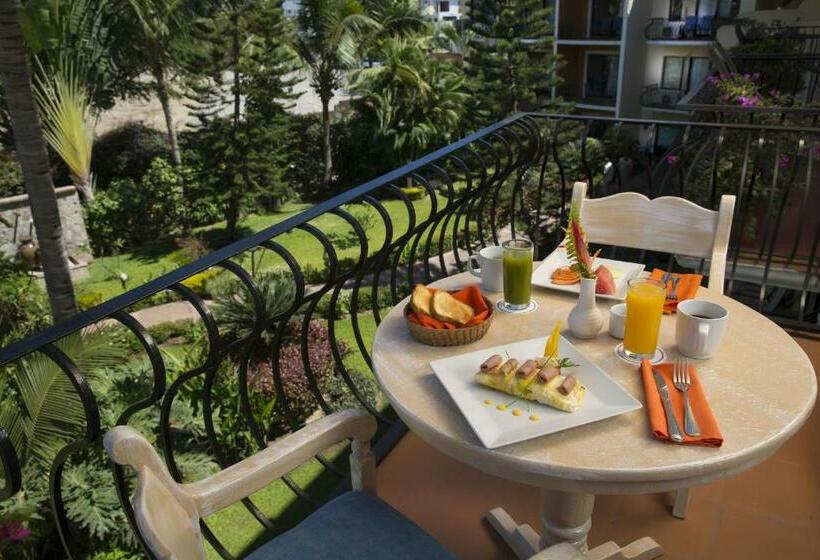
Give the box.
[379,332,820,560]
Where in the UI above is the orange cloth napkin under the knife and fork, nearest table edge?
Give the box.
[641,360,723,447]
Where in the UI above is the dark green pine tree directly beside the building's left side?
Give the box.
[464,0,558,126]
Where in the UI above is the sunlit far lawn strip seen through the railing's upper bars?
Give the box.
[77,197,452,301]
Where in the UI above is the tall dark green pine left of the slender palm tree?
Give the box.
[190,0,298,239]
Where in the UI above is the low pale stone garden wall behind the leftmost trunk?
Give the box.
[0,187,89,256]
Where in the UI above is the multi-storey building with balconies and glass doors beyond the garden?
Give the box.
[547,0,820,120]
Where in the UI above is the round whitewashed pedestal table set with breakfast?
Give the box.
[372,273,817,557]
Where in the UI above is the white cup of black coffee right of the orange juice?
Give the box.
[675,299,729,359]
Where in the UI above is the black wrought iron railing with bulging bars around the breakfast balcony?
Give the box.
[0,114,820,558]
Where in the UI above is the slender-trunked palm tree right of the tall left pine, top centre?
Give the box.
[296,0,380,189]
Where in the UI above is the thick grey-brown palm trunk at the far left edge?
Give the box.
[0,0,77,323]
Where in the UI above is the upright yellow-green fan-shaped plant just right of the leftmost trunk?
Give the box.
[34,61,94,202]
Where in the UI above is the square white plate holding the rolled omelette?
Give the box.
[430,337,642,448]
